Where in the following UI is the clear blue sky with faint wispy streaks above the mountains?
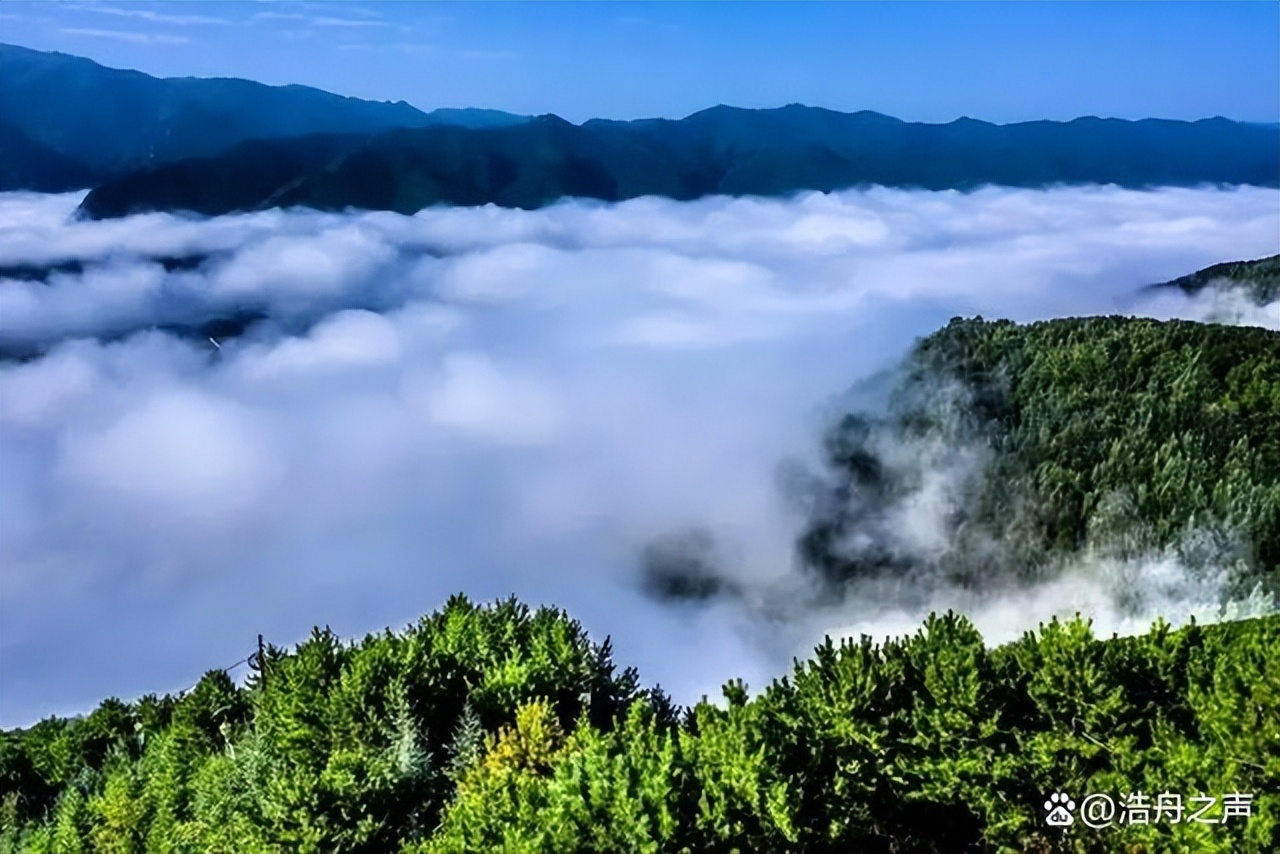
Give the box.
[0,0,1280,122]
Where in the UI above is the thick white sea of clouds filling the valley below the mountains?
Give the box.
[0,187,1280,726]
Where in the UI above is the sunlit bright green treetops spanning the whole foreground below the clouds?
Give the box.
[0,598,1280,854]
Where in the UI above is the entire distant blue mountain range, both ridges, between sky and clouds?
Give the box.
[0,46,1280,218]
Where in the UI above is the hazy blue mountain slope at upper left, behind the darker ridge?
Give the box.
[0,45,522,191]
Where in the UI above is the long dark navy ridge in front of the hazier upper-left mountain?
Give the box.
[83,105,1280,216]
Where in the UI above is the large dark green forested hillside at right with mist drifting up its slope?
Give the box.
[803,316,1280,604]
